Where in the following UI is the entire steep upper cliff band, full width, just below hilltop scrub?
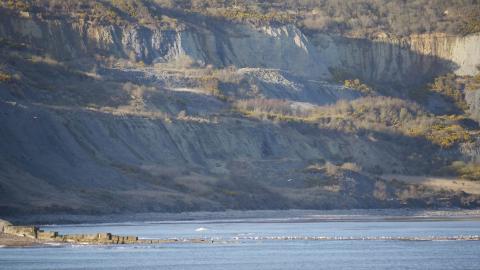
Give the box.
[0,13,480,86]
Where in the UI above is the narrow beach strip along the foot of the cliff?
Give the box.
[0,209,480,226]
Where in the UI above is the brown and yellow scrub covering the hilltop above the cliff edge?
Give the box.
[1,0,480,36]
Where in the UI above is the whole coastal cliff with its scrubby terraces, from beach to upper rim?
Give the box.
[0,2,480,216]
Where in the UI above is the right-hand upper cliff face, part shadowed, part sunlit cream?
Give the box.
[311,33,480,86]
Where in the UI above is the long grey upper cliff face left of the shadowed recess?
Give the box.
[0,14,329,79]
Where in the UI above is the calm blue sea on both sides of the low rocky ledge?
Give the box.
[0,220,480,270]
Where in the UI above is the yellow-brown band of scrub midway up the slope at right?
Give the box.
[234,96,472,148]
